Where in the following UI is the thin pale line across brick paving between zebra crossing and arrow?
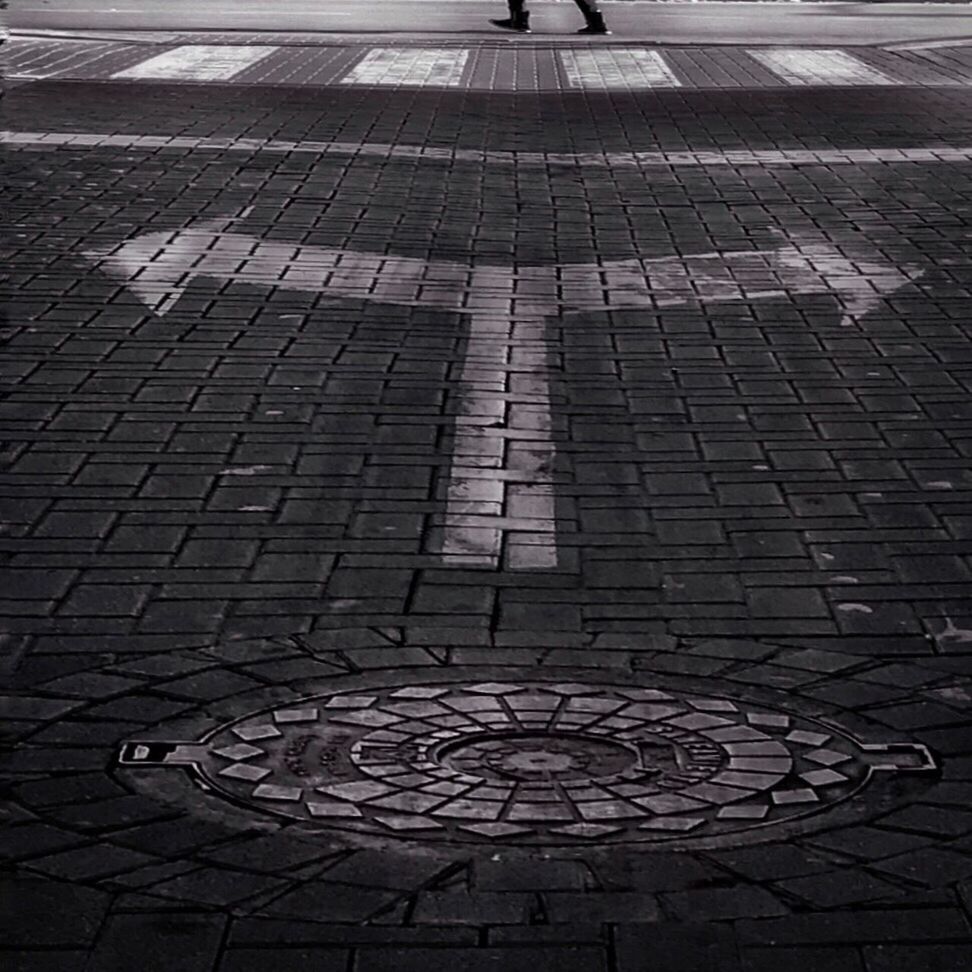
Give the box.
[7,131,972,169]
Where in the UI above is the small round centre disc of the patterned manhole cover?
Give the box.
[435,733,639,781]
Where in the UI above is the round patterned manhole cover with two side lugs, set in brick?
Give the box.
[120,678,934,844]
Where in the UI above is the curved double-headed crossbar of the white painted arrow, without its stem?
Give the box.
[86,220,917,322]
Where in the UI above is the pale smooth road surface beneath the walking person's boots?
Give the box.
[7,0,972,46]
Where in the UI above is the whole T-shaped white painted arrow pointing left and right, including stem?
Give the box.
[86,220,920,569]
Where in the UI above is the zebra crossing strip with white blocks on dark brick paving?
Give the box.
[7,39,972,91]
